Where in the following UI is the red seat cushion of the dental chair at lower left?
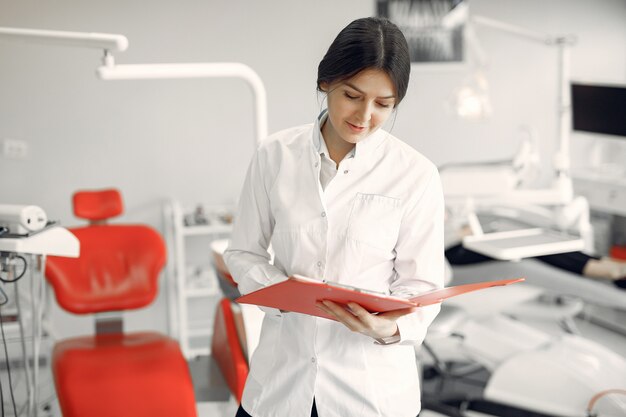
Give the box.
[52,333,196,417]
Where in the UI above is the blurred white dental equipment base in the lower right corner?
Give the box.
[423,302,626,417]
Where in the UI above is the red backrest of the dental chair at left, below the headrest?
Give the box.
[46,225,165,314]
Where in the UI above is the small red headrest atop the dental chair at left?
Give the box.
[72,188,124,221]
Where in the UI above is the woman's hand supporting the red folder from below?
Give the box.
[315,300,417,339]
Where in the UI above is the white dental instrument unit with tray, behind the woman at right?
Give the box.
[440,131,594,260]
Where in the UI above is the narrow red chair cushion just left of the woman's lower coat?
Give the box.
[211,298,248,402]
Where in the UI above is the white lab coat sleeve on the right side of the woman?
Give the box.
[390,167,445,345]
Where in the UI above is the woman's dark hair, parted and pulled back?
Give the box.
[317,17,411,107]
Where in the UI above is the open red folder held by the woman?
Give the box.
[235,275,524,320]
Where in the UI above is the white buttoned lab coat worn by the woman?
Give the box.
[224,115,444,417]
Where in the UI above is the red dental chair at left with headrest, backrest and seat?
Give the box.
[46,190,196,417]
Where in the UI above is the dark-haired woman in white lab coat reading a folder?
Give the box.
[224,18,444,417]
